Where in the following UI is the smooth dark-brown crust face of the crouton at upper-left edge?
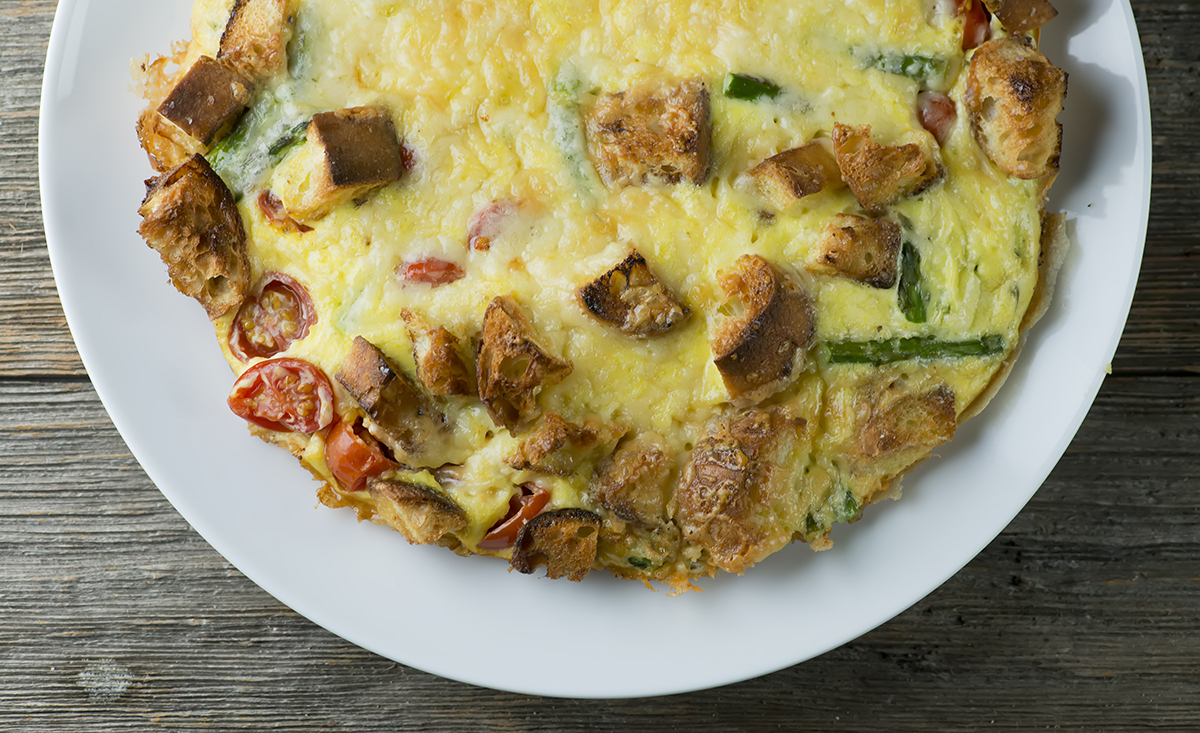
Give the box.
[158,56,254,146]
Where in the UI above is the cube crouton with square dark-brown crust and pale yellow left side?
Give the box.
[277,107,404,221]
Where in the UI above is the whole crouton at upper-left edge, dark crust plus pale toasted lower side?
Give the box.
[137,56,254,172]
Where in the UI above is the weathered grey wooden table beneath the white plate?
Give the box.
[0,0,1200,732]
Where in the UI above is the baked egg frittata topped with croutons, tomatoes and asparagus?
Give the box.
[134,0,1067,588]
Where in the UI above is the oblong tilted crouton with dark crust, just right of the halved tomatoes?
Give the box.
[336,336,445,465]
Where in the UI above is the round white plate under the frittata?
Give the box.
[41,0,1150,697]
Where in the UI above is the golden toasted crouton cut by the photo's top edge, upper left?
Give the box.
[217,0,295,83]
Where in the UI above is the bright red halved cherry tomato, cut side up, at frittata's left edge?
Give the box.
[229,359,334,433]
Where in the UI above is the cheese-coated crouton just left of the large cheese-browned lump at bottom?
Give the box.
[588,435,676,528]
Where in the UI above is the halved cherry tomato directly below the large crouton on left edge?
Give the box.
[229,272,317,362]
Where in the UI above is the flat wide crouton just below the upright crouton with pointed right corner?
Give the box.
[504,411,624,476]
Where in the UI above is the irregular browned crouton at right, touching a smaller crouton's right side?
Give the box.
[833,122,943,215]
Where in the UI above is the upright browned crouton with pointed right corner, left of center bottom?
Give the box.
[475,295,572,433]
